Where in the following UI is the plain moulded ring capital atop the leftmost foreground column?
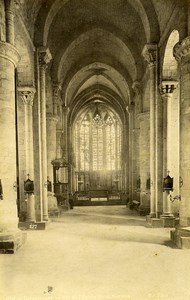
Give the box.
[0,41,20,67]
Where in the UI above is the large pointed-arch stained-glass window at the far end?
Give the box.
[74,105,121,172]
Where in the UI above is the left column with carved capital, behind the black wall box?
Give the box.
[17,86,36,221]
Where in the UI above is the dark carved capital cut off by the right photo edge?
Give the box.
[173,36,190,62]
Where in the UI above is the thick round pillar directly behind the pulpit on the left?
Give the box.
[47,114,58,183]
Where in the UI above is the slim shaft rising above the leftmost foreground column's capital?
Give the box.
[5,0,14,45]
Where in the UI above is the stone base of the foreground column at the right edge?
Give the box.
[170,227,190,249]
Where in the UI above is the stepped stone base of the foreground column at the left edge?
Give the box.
[0,230,27,254]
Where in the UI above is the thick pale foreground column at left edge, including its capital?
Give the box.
[0,42,19,232]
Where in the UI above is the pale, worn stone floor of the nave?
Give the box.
[0,206,190,300]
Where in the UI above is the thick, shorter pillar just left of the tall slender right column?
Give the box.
[137,112,150,215]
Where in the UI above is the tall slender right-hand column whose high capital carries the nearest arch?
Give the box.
[142,44,157,218]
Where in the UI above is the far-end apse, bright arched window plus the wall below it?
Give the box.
[73,100,122,191]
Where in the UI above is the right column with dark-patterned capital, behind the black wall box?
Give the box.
[160,81,177,227]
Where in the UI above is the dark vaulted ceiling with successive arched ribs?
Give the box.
[17,0,184,122]
